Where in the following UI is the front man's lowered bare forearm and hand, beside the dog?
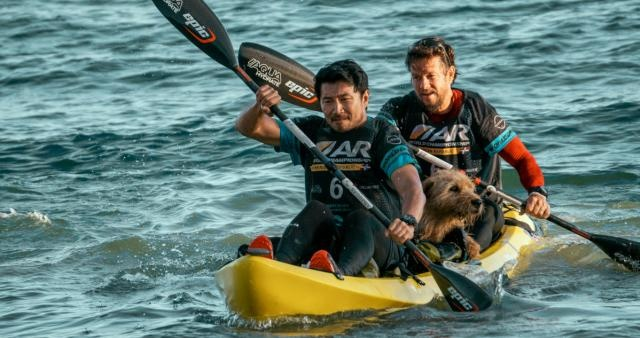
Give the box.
[388,164,426,243]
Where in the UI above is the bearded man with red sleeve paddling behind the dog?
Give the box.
[379,37,551,250]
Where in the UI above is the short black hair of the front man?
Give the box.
[314,59,369,97]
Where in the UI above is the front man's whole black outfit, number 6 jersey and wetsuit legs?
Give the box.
[275,116,419,275]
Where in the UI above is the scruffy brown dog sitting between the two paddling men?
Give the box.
[416,169,482,258]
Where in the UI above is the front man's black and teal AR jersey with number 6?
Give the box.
[276,116,419,223]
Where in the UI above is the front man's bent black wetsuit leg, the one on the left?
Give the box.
[275,200,336,265]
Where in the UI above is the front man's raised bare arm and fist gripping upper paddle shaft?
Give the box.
[236,85,280,146]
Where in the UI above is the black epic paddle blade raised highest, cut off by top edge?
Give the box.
[153,0,238,69]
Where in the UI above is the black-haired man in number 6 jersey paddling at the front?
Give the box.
[236,60,425,275]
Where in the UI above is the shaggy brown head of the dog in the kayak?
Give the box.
[423,169,482,225]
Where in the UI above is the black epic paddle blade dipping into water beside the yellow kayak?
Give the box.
[429,255,493,312]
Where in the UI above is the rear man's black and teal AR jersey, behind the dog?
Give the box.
[378,89,516,187]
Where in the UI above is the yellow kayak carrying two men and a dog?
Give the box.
[215,211,536,320]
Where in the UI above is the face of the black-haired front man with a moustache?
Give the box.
[320,81,369,133]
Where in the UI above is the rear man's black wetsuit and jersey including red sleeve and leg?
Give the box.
[378,89,544,249]
